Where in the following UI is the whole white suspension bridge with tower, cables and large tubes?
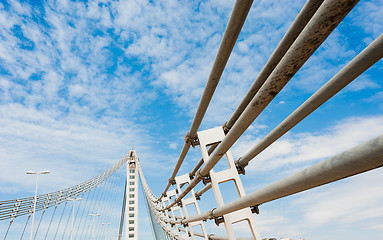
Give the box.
[0,0,383,240]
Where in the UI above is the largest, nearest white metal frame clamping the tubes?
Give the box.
[197,127,261,240]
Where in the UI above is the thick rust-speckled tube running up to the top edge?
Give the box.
[167,0,359,209]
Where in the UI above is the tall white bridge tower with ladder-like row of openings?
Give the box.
[125,150,138,240]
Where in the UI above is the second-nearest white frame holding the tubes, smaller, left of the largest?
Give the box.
[175,174,208,240]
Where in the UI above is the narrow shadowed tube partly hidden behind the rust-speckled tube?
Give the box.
[226,0,323,129]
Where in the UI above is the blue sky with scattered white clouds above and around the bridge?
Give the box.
[0,0,383,239]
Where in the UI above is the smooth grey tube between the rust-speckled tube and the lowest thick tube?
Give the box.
[236,34,383,168]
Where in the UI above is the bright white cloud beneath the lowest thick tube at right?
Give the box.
[294,171,383,227]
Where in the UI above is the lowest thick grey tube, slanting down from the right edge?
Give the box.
[180,135,383,224]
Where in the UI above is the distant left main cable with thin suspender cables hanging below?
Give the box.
[0,158,126,240]
